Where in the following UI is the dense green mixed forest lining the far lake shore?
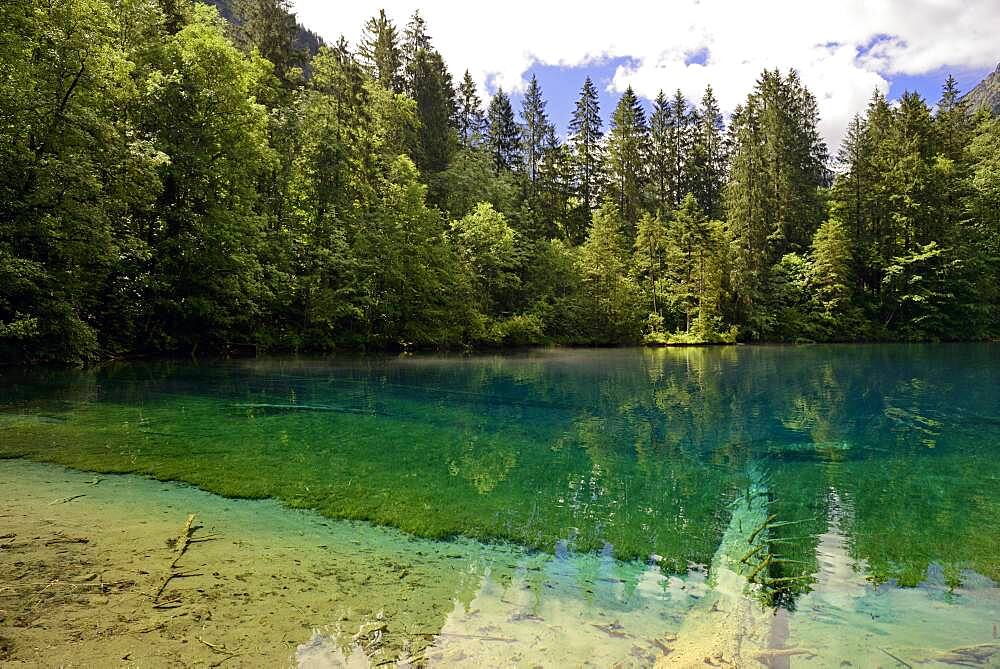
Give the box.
[0,0,1000,363]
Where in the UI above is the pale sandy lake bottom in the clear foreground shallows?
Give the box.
[0,460,1000,667]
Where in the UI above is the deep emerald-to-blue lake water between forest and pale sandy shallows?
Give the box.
[0,344,1000,664]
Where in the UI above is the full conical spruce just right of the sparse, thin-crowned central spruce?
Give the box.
[607,86,649,228]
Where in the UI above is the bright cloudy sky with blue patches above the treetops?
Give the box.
[292,0,1000,152]
